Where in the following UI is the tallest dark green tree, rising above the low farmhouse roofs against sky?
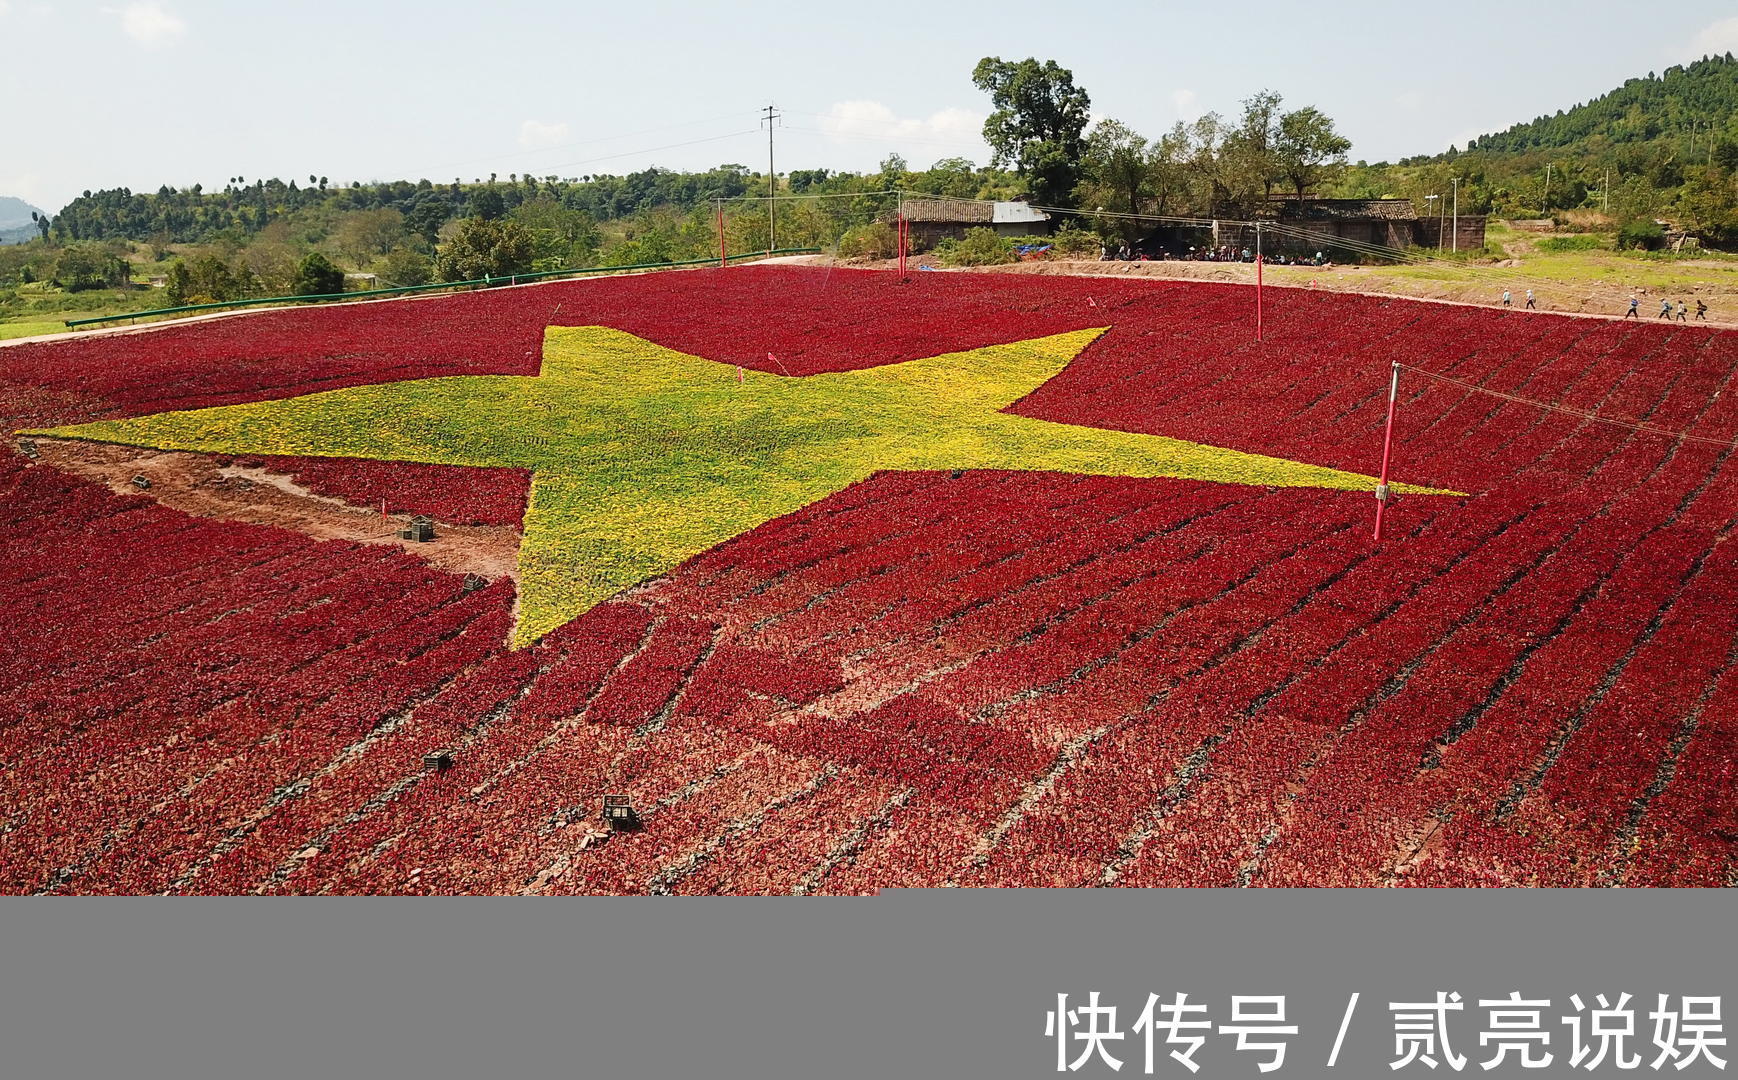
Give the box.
[972,56,1091,207]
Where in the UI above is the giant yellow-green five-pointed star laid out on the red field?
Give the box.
[23,327,1452,647]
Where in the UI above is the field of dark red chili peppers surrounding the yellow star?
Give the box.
[0,266,1738,894]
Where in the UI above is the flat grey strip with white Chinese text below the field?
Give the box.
[0,890,1738,1080]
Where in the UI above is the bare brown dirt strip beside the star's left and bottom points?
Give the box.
[33,437,520,581]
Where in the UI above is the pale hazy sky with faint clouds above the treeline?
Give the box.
[0,0,1738,210]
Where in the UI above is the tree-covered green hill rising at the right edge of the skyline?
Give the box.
[1467,52,1738,160]
